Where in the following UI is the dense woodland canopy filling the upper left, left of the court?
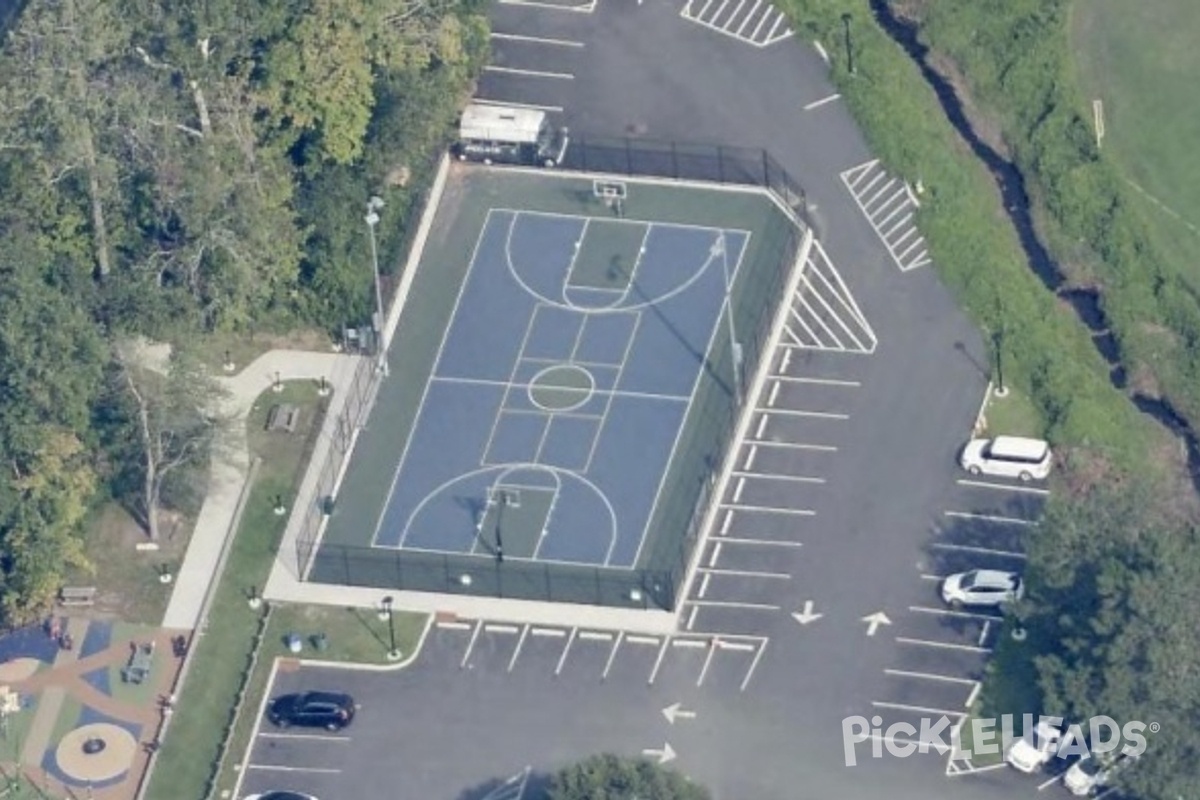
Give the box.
[0,0,487,622]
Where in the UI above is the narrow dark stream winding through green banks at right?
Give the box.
[871,0,1200,492]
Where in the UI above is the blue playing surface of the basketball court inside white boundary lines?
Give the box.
[373,209,750,569]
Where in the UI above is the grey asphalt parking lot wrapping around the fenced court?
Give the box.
[229,0,1084,800]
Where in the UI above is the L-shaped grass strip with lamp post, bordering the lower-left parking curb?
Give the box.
[216,606,428,796]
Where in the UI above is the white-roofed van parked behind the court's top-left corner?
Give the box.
[455,103,570,167]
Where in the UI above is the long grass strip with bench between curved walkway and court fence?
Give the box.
[146,380,326,800]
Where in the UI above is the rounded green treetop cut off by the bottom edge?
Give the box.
[548,754,712,800]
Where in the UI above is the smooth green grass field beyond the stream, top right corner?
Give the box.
[1070,0,1200,289]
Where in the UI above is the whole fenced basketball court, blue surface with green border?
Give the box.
[313,169,796,599]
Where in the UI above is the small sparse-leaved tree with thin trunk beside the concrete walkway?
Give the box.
[116,344,224,541]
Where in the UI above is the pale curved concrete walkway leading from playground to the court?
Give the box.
[162,350,361,630]
